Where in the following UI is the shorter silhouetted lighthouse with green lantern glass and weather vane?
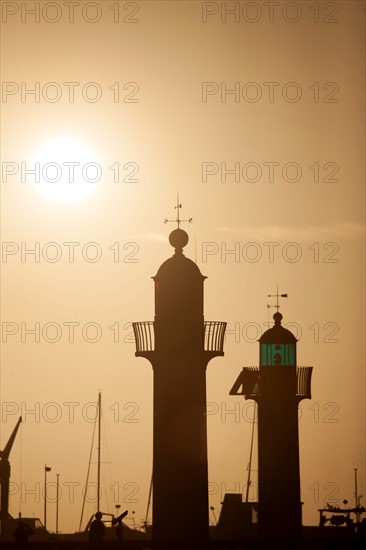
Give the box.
[230,291,312,542]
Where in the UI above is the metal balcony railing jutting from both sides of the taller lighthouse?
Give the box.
[132,321,226,353]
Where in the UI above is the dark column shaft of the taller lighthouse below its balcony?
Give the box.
[153,355,209,542]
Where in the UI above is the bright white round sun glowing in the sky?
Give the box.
[32,137,98,202]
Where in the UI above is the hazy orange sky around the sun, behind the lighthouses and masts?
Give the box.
[0,0,366,532]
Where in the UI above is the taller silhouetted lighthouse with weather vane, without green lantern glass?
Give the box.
[133,205,226,548]
